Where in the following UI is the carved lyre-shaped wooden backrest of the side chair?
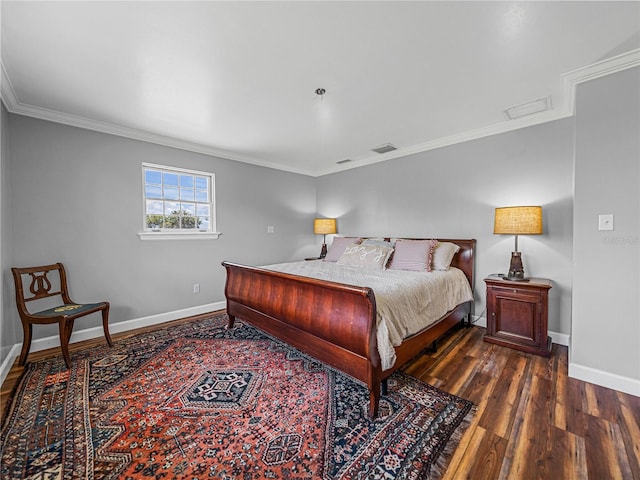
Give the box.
[11,263,73,316]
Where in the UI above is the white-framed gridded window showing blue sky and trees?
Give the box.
[140,163,218,239]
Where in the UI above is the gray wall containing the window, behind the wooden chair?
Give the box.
[3,114,319,352]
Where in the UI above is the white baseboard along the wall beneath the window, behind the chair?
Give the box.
[0,301,227,385]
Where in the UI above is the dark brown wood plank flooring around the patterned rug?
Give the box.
[0,319,640,480]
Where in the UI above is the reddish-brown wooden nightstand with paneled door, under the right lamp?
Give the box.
[484,276,551,357]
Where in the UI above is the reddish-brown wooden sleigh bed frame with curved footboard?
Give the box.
[222,239,476,418]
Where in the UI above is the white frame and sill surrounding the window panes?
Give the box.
[138,162,222,240]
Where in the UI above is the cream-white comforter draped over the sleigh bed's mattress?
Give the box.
[263,260,473,370]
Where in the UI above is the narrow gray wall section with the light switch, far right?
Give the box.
[571,68,640,382]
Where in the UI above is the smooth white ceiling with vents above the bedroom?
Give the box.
[1,0,640,175]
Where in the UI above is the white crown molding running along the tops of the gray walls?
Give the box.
[0,49,640,177]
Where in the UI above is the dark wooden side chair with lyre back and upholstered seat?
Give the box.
[11,263,113,368]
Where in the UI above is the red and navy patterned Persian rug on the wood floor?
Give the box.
[0,314,473,480]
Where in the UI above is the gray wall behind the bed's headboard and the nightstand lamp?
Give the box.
[318,119,574,335]
